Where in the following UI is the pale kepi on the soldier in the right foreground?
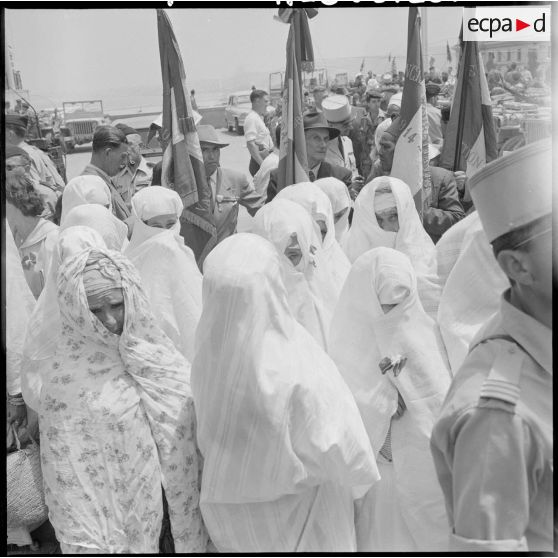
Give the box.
[469,139,552,242]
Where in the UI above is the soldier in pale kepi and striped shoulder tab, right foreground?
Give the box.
[431,141,554,554]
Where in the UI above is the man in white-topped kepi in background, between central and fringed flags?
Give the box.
[322,95,358,177]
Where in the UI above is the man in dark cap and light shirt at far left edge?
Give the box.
[4,114,65,190]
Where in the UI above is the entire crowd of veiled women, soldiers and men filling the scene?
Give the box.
[4,57,554,554]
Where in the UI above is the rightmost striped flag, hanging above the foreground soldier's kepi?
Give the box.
[440,24,498,176]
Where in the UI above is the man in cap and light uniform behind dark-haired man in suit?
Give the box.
[113,123,154,211]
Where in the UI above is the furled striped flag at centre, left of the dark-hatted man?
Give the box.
[277,8,317,191]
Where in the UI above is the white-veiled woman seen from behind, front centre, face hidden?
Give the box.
[192,234,378,553]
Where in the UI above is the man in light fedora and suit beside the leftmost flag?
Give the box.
[198,124,265,242]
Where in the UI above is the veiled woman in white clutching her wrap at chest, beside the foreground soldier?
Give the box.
[329,248,450,552]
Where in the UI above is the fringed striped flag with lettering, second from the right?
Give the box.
[391,6,432,219]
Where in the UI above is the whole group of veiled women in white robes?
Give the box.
[5,136,552,554]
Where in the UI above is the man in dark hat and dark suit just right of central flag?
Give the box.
[267,112,362,202]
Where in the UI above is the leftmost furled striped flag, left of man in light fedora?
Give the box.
[157,10,217,269]
